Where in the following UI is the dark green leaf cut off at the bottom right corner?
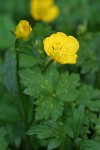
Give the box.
[78,139,100,150]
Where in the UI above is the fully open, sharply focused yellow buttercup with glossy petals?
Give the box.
[43,32,79,64]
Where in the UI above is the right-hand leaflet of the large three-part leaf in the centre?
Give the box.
[56,73,79,101]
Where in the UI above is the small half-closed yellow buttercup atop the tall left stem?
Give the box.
[15,20,32,40]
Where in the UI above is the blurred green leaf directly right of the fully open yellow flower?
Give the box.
[77,40,99,74]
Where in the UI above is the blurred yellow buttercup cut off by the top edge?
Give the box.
[30,0,59,22]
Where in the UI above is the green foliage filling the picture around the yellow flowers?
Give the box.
[0,0,100,150]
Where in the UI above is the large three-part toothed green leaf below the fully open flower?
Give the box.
[20,68,79,120]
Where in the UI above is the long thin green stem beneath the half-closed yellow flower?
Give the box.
[15,40,35,150]
